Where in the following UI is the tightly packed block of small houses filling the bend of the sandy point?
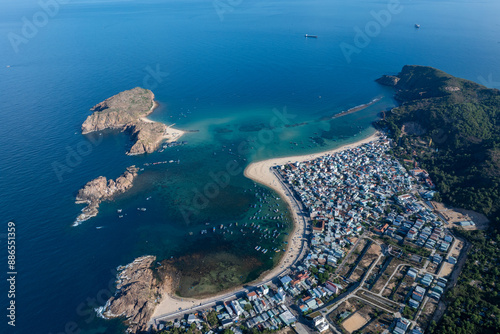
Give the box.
[277,138,408,267]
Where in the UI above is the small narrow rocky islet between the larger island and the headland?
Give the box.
[73,166,139,226]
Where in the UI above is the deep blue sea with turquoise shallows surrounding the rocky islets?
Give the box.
[0,0,500,334]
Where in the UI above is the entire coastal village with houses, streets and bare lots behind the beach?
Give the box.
[151,136,474,334]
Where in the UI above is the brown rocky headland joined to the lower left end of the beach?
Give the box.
[97,255,179,333]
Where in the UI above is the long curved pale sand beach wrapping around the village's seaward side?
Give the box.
[150,132,379,322]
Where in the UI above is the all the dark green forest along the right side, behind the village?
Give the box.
[378,66,500,334]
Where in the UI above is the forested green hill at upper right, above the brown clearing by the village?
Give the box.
[378,66,500,222]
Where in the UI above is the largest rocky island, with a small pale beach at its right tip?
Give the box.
[82,87,183,155]
